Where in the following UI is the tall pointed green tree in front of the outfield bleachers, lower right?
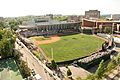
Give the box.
[95,60,105,79]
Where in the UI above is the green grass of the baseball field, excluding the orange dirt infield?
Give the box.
[40,34,103,62]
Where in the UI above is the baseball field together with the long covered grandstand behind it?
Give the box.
[19,21,104,62]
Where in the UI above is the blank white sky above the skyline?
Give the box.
[0,0,120,17]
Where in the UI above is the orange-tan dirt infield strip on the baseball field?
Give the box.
[33,36,60,45]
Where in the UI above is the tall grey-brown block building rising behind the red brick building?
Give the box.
[85,10,100,19]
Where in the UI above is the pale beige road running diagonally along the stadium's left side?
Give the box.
[15,40,53,80]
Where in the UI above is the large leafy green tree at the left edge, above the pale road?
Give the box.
[0,29,15,58]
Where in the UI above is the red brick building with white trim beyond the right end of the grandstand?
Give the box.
[82,19,120,32]
